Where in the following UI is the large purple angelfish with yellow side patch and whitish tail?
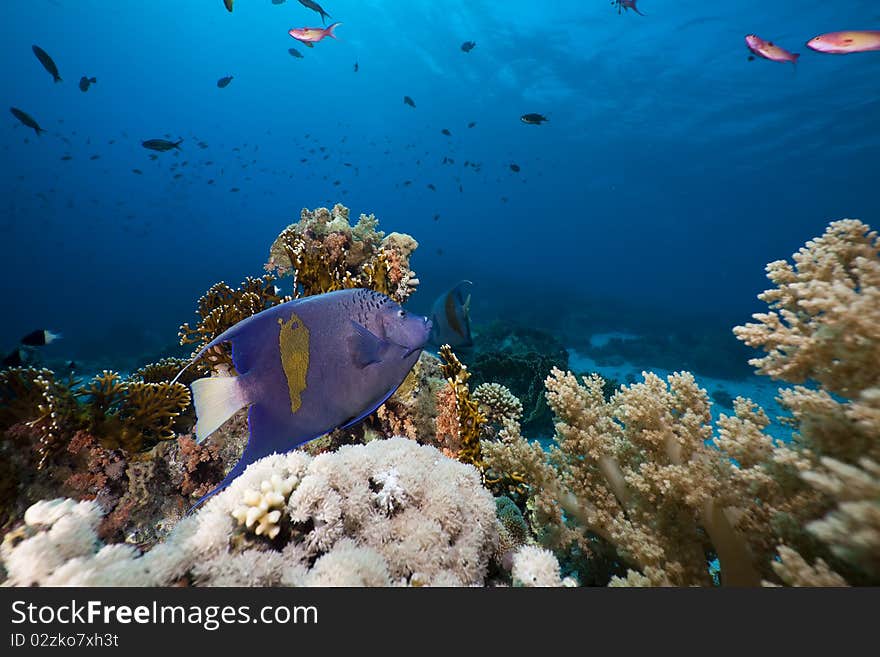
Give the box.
[177,288,431,506]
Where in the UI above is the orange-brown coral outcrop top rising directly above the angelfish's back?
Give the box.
[265,203,419,303]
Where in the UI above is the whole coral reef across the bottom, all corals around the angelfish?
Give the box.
[0,217,880,586]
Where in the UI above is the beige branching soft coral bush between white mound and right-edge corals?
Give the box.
[484,369,760,585]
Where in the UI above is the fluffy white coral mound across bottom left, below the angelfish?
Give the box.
[0,438,498,586]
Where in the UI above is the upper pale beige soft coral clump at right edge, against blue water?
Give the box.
[734,219,880,398]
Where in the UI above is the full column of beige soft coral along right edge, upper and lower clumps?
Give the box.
[721,219,880,583]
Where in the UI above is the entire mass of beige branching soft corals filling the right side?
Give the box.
[483,221,880,586]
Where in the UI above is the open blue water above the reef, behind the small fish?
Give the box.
[0,0,880,368]
